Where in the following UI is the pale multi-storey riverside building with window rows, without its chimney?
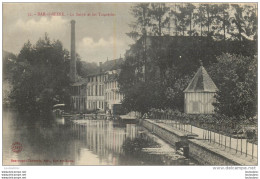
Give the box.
[86,58,123,112]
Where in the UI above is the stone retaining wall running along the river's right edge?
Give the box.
[141,119,253,165]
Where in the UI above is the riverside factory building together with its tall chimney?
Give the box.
[70,20,123,112]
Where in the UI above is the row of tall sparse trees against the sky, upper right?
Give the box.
[128,3,257,40]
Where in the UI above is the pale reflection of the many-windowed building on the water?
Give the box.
[73,120,138,160]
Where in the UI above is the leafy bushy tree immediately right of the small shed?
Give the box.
[209,54,257,119]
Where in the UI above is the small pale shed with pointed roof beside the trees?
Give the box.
[184,66,218,114]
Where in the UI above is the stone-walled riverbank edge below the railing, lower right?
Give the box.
[141,119,257,165]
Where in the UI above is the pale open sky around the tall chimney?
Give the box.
[3,3,134,63]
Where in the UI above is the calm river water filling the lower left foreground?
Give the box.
[3,109,194,165]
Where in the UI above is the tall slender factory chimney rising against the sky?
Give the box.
[70,20,76,82]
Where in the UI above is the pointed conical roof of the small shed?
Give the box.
[184,66,218,92]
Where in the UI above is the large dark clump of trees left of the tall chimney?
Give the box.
[10,34,69,114]
